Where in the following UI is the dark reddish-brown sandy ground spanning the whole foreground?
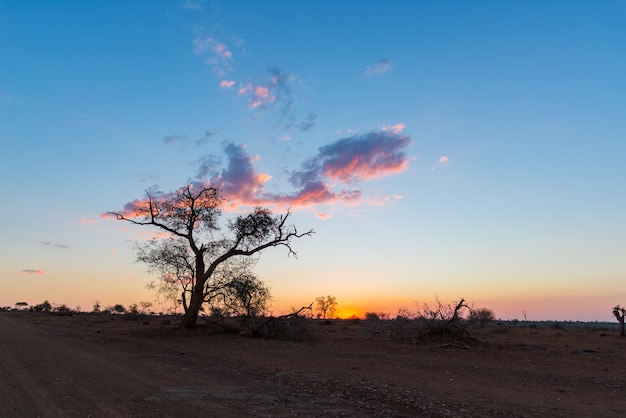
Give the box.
[0,312,626,417]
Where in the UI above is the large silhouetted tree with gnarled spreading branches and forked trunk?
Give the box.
[110,185,313,328]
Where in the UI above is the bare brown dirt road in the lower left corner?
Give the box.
[0,315,264,417]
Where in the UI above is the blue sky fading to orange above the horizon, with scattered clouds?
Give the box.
[0,0,626,321]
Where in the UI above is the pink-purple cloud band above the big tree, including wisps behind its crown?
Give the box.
[107,129,411,219]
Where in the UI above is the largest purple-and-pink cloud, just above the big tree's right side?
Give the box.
[211,131,411,207]
